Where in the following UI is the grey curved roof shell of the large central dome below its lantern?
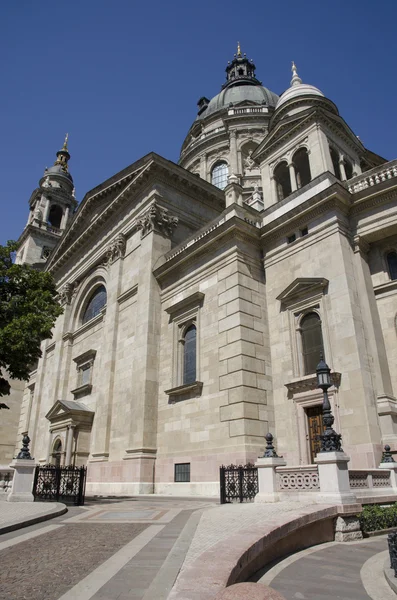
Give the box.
[197,85,278,119]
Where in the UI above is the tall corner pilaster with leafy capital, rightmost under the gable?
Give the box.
[124,202,178,493]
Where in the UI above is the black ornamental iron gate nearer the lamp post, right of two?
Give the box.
[219,463,259,504]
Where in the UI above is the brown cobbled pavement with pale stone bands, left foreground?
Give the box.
[0,497,214,600]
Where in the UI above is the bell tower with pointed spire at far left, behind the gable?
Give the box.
[16,134,77,268]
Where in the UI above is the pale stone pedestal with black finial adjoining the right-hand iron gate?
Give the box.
[255,433,287,503]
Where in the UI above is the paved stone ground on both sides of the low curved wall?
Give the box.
[0,496,395,600]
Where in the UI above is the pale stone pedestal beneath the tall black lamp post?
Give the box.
[314,452,358,504]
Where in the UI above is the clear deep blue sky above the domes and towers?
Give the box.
[0,0,397,243]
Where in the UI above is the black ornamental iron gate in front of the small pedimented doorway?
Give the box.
[33,465,87,506]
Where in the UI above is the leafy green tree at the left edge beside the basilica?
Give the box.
[0,241,63,408]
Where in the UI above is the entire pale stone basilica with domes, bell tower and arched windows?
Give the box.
[13,47,397,495]
